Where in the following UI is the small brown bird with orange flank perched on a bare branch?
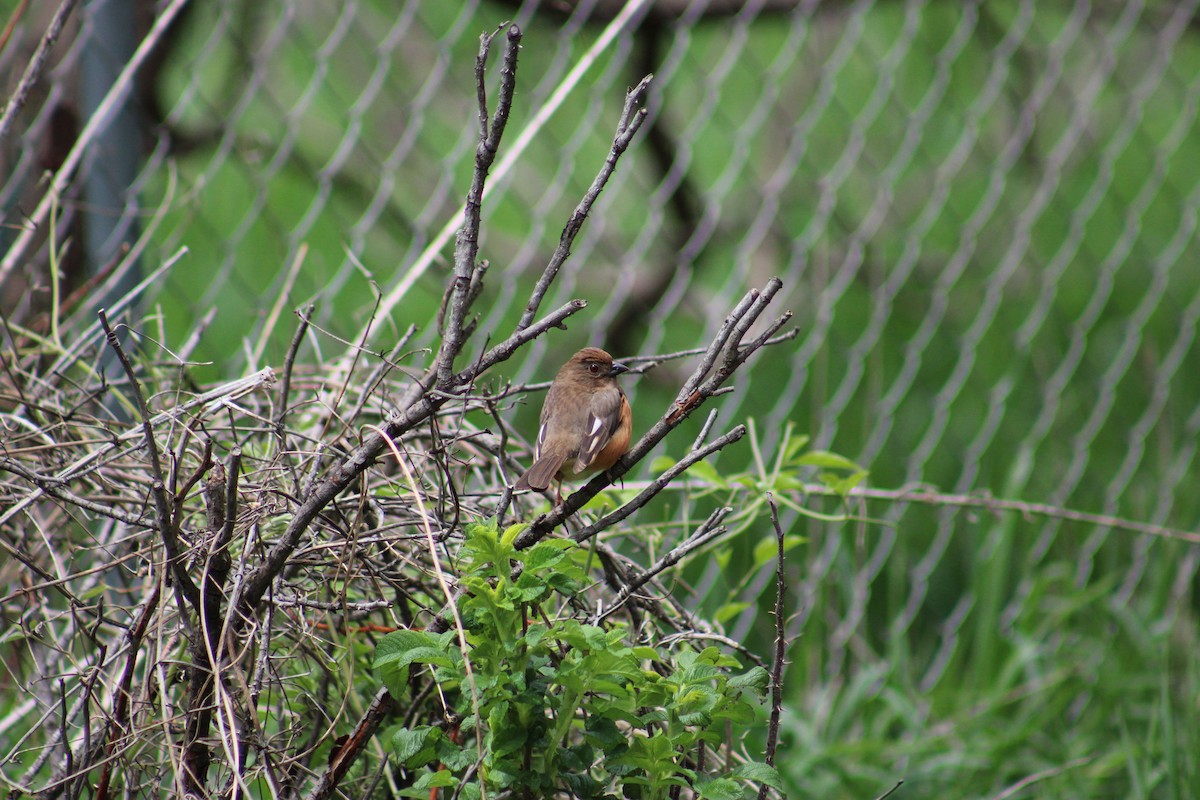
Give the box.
[514,348,634,492]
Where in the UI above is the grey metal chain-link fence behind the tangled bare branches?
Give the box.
[0,0,1200,796]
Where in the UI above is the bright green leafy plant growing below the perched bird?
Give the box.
[374,523,779,799]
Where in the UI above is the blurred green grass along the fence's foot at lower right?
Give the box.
[758,527,1200,800]
